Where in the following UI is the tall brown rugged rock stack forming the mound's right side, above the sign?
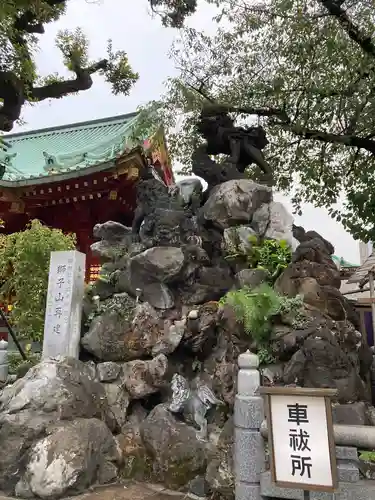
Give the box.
[272,228,372,403]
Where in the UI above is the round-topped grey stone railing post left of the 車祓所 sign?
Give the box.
[234,351,265,500]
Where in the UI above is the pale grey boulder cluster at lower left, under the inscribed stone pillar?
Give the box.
[0,358,121,498]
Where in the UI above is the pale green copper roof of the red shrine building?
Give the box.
[0,113,137,181]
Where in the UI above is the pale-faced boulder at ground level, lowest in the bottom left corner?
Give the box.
[15,419,121,499]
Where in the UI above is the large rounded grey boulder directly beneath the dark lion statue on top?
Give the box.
[201,179,272,230]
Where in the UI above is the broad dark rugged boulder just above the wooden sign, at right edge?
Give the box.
[270,306,372,403]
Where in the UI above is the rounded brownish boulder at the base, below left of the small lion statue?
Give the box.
[141,405,206,488]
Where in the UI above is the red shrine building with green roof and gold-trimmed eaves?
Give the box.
[0,113,173,282]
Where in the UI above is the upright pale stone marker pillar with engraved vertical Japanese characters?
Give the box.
[42,250,86,359]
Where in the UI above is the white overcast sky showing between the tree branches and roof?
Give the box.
[14,0,359,263]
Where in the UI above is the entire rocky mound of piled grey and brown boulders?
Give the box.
[0,170,372,498]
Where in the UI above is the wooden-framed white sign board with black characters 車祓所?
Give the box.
[260,387,338,492]
